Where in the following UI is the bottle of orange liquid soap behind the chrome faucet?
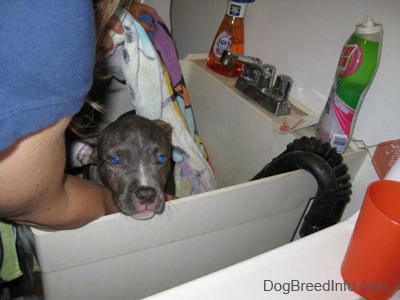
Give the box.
[207,0,254,77]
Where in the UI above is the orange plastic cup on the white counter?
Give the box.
[341,180,400,299]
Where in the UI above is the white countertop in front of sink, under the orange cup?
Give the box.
[146,214,400,300]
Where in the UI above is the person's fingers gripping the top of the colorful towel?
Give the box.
[96,3,157,61]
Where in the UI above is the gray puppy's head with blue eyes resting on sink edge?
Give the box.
[71,114,172,219]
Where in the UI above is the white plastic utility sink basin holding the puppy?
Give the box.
[33,60,365,299]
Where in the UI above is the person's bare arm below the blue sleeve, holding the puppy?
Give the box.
[0,117,118,230]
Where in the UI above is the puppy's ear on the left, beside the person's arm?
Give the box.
[70,136,97,168]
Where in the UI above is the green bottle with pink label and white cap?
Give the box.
[317,16,383,153]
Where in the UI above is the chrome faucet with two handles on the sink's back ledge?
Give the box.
[220,50,293,116]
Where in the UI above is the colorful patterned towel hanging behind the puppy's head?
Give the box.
[99,8,217,197]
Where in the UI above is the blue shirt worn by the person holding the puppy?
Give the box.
[0,0,95,151]
